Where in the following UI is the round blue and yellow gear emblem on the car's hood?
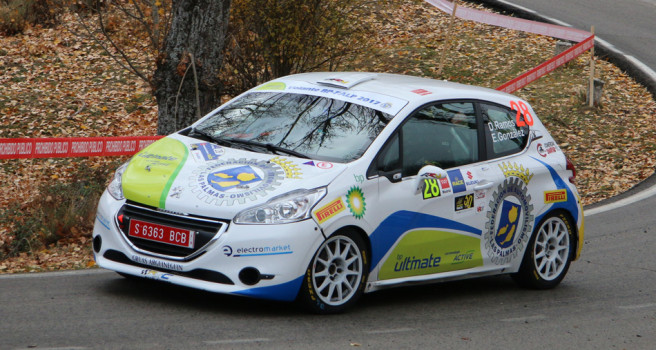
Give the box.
[189,158,284,205]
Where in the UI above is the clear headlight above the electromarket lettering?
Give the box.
[234,187,326,224]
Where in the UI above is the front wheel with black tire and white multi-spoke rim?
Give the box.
[298,230,369,314]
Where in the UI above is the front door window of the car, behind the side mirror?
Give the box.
[401,102,479,176]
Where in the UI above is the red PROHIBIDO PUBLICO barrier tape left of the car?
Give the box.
[0,136,163,159]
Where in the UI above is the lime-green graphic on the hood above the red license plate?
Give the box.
[123,137,189,209]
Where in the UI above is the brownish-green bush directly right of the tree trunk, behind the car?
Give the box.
[224,0,394,94]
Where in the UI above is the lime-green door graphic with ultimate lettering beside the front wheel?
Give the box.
[379,230,483,280]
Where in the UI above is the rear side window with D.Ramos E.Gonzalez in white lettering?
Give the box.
[481,103,529,158]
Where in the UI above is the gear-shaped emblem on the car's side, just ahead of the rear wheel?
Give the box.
[483,177,534,265]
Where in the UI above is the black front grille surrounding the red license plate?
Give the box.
[116,202,228,260]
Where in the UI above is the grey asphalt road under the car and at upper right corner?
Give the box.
[0,0,656,349]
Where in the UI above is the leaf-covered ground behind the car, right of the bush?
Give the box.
[354,0,656,205]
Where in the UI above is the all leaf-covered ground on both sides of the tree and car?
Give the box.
[0,0,656,273]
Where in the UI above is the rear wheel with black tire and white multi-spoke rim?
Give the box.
[512,212,576,289]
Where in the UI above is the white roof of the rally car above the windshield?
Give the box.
[275,72,518,106]
